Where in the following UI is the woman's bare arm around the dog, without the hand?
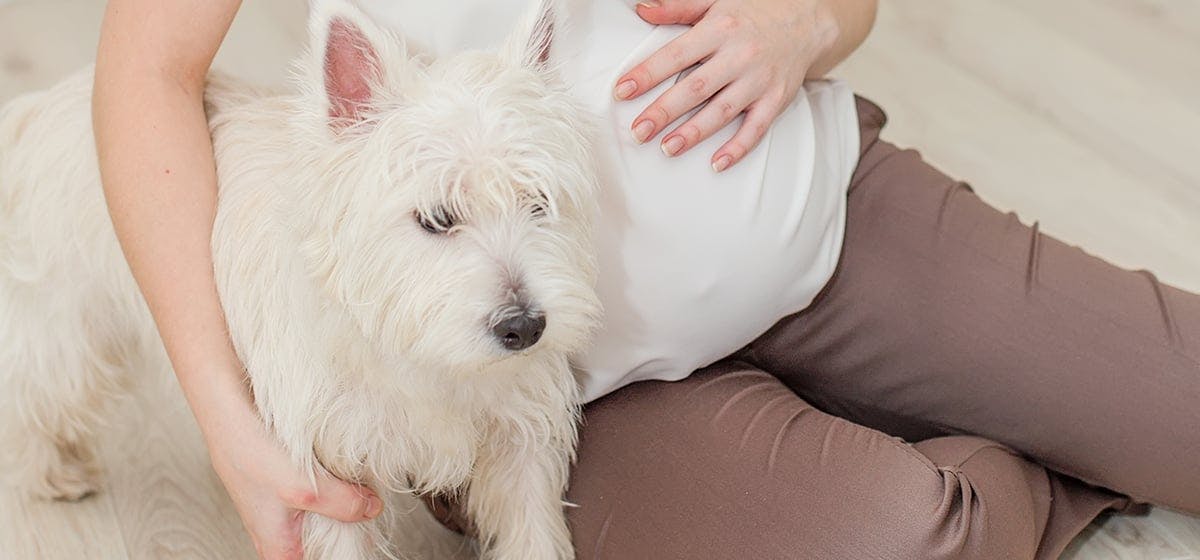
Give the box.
[92,0,250,433]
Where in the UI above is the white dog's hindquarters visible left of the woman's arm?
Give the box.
[0,72,148,500]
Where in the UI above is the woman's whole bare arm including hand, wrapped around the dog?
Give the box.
[92,0,383,559]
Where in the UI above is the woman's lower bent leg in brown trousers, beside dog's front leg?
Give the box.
[568,362,1114,560]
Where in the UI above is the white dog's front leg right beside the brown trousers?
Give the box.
[467,417,575,560]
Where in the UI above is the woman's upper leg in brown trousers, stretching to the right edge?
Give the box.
[739,97,1200,511]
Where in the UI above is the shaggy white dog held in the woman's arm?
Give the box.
[0,1,600,560]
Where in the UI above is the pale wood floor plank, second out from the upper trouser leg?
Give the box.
[896,0,1200,209]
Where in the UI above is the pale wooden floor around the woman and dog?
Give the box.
[0,0,1200,560]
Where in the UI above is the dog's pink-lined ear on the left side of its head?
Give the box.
[305,0,407,131]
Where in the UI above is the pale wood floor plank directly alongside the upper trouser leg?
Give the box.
[836,2,1200,289]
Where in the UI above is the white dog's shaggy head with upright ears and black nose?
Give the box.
[282,0,599,371]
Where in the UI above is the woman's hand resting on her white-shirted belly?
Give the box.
[614,0,875,173]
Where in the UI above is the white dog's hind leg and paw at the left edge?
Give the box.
[0,256,143,500]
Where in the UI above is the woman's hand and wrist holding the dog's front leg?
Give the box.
[205,386,383,560]
